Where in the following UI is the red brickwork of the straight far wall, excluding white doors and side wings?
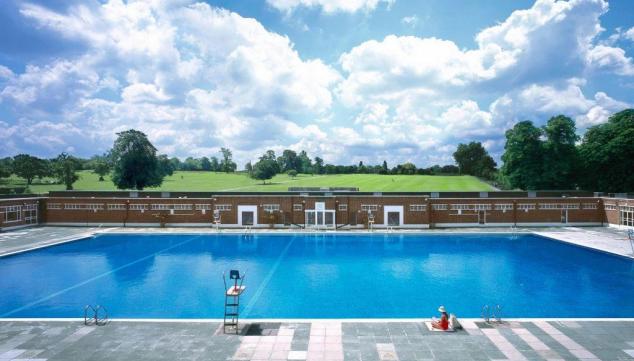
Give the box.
[42,195,618,227]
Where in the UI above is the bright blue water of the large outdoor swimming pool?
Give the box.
[0,234,634,318]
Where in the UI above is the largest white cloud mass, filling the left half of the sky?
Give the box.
[0,0,340,162]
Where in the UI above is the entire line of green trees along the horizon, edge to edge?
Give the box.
[0,109,634,192]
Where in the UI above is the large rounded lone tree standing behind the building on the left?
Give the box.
[112,129,164,190]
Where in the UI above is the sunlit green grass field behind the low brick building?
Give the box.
[0,171,493,193]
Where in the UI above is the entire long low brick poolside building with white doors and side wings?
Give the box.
[0,191,634,229]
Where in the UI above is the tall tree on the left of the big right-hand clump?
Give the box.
[501,120,543,190]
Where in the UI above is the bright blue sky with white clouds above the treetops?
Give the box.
[0,0,634,168]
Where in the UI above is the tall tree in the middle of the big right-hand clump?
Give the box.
[541,115,579,189]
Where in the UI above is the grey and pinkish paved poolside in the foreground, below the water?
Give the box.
[0,320,634,361]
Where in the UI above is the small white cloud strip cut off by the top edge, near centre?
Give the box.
[266,0,395,14]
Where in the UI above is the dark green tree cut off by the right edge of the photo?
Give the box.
[579,109,634,192]
